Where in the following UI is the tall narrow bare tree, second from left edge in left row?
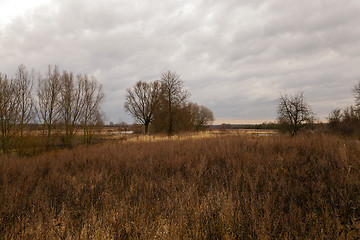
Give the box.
[15,65,34,138]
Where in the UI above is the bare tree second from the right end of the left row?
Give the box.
[60,71,85,146]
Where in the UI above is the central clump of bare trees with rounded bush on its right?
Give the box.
[124,71,214,135]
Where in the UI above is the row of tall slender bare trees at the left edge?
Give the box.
[0,65,104,153]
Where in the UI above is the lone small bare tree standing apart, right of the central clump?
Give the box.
[277,92,314,136]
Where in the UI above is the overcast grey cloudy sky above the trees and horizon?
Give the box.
[0,0,360,124]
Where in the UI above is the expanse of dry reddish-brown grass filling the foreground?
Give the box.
[0,135,360,239]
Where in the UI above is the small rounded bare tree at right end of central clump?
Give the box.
[189,103,214,131]
